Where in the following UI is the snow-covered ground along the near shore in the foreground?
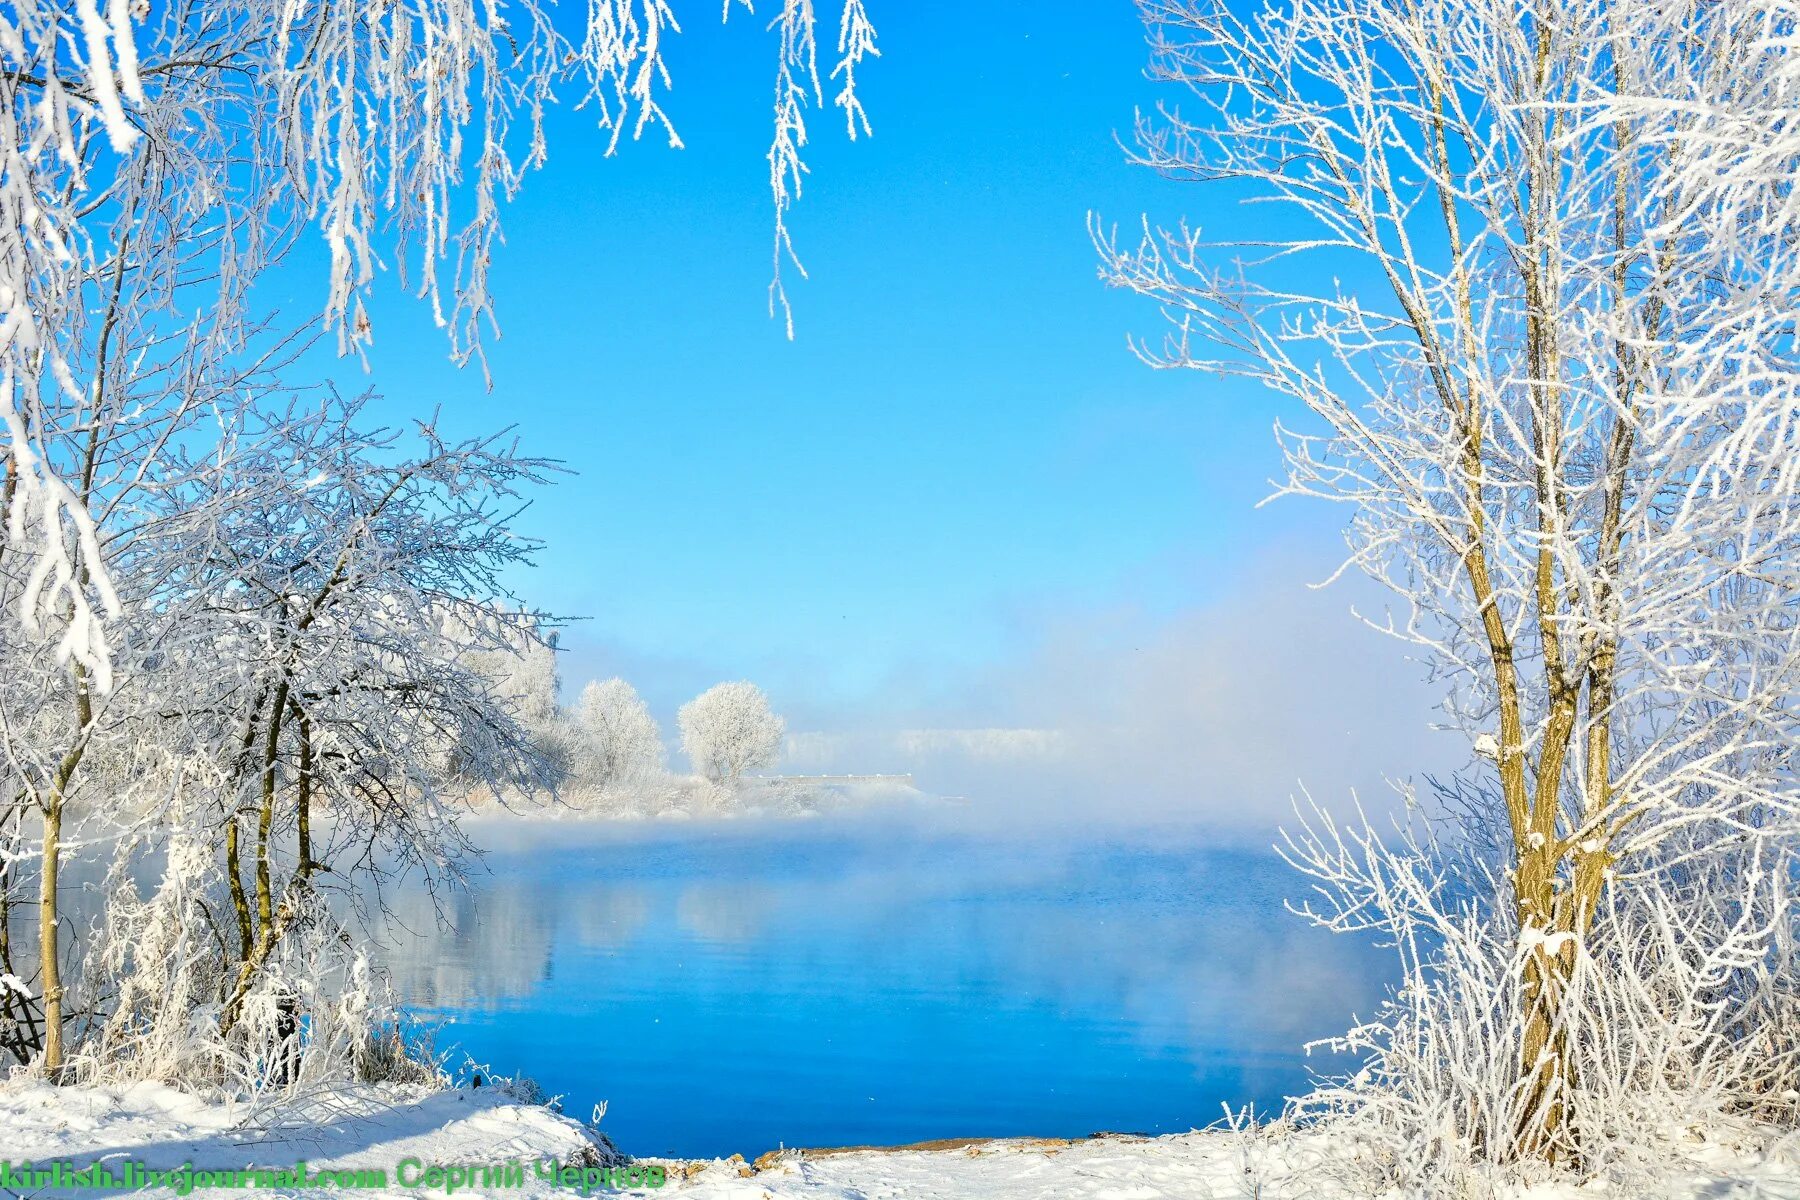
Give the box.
[0,1081,1800,1200]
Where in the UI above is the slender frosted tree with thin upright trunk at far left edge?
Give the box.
[0,203,302,1067]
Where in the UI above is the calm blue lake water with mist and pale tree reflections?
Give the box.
[365,822,1382,1155]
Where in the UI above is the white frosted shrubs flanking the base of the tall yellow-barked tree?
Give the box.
[1287,788,1800,1195]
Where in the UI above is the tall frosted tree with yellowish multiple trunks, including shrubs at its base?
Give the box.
[1096,0,1800,1169]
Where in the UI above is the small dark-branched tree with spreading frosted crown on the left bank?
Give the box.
[169,403,561,1031]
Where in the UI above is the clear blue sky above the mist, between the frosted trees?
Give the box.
[273,0,1440,816]
